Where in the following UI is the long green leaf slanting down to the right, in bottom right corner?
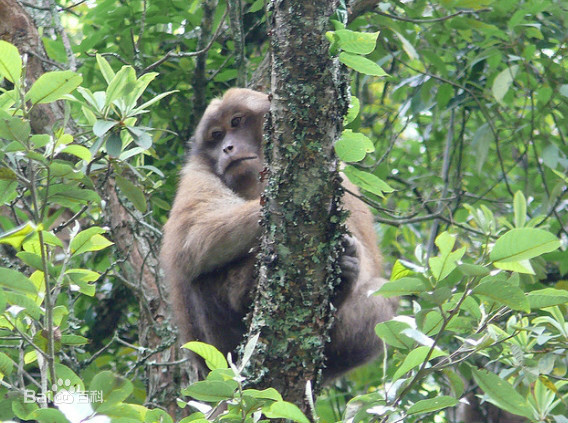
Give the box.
[472,369,534,419]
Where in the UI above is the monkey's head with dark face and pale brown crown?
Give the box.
[192,88,270,198]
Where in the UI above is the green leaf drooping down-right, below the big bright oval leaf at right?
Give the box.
[473,274,530,313]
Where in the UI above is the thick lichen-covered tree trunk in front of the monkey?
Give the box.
[245,0,348,410]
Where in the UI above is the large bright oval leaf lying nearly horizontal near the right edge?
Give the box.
[489,228,560,263]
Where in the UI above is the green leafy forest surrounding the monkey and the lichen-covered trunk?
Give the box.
[0,0,568,423]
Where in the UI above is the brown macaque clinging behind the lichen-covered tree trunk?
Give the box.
[161,88,396,380]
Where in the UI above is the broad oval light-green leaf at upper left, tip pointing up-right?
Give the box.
[26,71,83,104]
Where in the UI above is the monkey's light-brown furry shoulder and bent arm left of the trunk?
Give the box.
[162,162,260,279]
